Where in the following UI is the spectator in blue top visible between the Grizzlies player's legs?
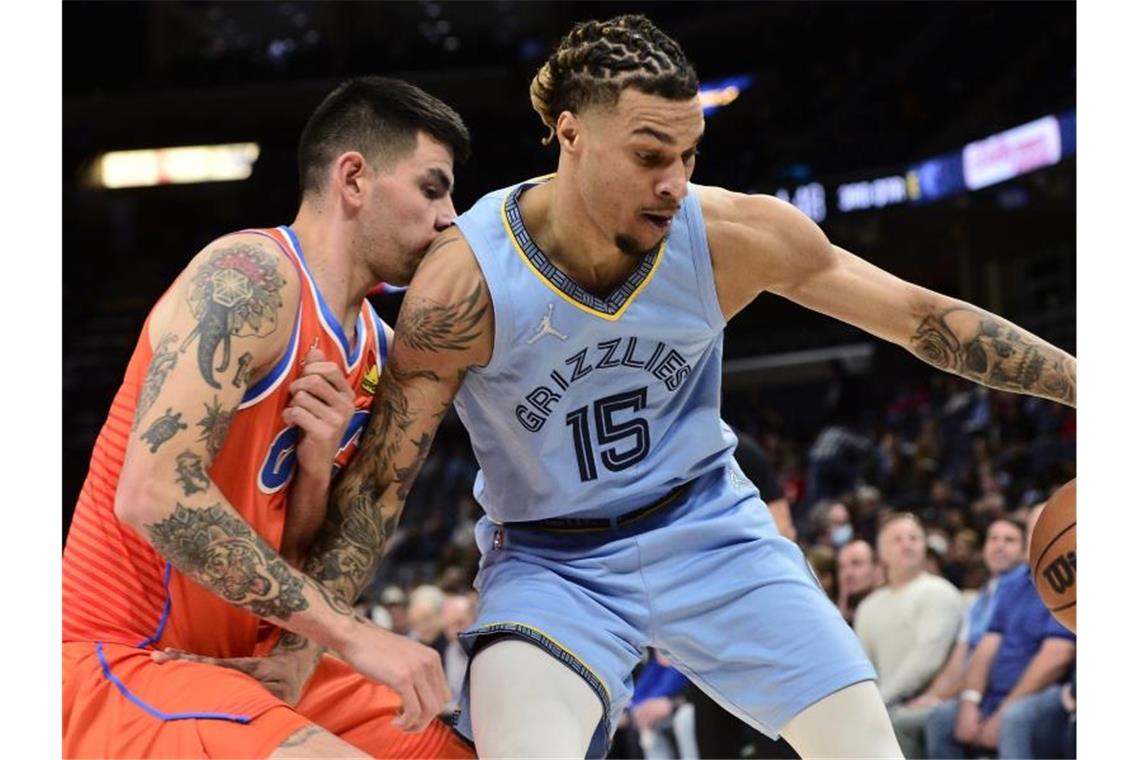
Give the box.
[628,649,701,760]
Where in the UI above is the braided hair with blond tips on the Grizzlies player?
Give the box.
[530,14,698,145]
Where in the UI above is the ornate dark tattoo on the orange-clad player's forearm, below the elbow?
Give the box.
[147,504,309,620]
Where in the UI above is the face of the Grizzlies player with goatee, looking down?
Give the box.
[580,89,705,255]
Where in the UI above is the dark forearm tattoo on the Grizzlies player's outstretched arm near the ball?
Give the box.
[911,305,1076,406]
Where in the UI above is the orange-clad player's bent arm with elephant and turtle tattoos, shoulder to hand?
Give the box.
[115,235,448,729]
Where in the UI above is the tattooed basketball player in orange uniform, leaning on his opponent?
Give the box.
[63,77,471,758]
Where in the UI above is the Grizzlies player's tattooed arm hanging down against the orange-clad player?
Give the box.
[306,227,495,600]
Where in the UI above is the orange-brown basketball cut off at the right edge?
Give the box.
[1029,479,1076,634]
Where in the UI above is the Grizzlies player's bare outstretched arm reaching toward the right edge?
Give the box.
[698,188,1076,406]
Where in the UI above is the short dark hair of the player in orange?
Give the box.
[298,76,471,195]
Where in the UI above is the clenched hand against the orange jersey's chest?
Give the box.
[282,349,356,476]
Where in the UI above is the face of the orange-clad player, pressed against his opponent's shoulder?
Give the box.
[364,132,455,285]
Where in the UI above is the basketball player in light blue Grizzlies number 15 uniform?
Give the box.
[334,16,1076,758]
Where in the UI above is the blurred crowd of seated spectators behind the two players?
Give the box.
[351,374,1076,758]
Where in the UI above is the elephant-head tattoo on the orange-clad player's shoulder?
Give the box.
[181,243,285,389]
